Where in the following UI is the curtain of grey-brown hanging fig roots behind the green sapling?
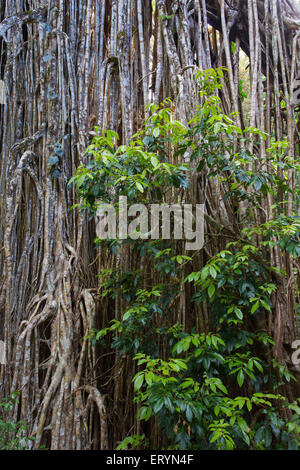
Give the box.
[0,0,300,449]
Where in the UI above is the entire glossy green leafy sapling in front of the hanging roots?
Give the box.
[71,69,300,450]
